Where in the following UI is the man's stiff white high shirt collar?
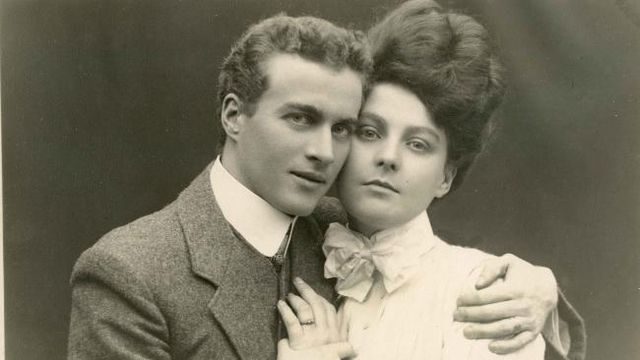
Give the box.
[209,156,293,256]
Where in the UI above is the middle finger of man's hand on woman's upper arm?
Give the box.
[453,300,530,323]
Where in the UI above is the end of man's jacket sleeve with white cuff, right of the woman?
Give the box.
[542,289,587,360]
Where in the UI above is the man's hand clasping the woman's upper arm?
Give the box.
[454,254,558,354]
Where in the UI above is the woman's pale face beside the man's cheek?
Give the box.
[337,83,455,235]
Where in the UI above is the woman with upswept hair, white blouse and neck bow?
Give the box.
[279,1,544,360]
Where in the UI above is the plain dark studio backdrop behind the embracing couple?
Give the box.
[1,0,640,360]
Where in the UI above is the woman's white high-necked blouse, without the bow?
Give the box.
[330,213,545,360]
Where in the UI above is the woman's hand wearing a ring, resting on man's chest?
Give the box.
[278,278,342,350]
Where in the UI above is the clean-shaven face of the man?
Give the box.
[231,54,363,216]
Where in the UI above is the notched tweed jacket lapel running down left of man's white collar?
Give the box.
[178,165,278,359]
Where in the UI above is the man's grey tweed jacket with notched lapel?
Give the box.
[68,165,335,360]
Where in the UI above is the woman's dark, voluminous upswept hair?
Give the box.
[368,0,505,190]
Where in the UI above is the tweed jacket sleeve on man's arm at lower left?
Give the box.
[68,248,171,360]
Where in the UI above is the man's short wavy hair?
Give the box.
[217,14,372,145]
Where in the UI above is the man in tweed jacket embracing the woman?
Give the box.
[69,12,584,359]
